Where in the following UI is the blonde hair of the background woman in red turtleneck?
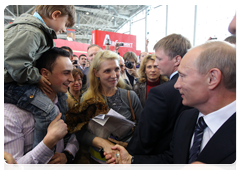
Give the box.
[138,54,168,83]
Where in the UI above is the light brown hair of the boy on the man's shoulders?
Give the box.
[32,5,76,27]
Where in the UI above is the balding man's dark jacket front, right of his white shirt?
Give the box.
[197,111,238,165]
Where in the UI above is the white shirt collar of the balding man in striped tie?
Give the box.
[198,99,238,134]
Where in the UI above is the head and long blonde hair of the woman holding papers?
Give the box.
[83,51,125,102]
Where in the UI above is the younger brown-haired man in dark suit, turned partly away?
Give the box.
[127,34,191,155]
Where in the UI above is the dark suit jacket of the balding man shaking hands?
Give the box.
[134,109,238,170]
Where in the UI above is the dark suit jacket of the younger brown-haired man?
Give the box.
[127,74,189,155]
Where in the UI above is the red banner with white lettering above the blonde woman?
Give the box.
[92,30,141,56]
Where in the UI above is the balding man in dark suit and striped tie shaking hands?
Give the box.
[106,41,238,170]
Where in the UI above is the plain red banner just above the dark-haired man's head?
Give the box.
[54,39,89,56]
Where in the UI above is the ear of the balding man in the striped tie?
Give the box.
[208,68,222,90]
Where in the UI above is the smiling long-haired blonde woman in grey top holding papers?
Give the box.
[66,51,142,169]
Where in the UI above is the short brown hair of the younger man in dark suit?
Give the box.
[153,34,191,59]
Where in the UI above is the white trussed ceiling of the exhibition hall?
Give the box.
[4,5,149,43]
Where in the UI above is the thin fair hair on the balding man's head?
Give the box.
[196,41,238,91]
